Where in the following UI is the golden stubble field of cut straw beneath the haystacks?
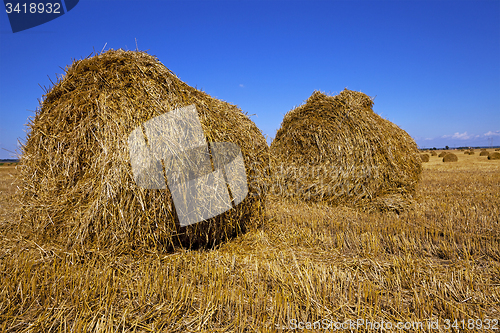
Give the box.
[0,154,500,332]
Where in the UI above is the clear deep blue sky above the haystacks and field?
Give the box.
[0,0,500,158]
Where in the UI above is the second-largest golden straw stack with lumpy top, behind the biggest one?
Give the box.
[271,89,421,210]
